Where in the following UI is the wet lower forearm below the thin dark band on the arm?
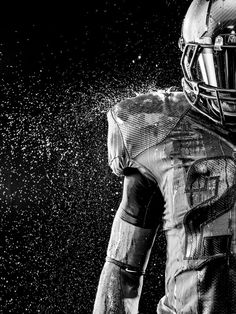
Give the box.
[93,262,143,314]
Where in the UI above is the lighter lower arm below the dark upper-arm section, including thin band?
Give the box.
[93,216,156,314]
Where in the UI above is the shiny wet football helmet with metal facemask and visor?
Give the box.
[179,0,236,128]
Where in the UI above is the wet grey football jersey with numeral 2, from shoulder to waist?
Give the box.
[108,91,236,314]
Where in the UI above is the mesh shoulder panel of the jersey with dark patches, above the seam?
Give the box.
[108,91,190,175]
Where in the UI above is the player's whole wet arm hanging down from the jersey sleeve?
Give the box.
[93,169,162,314]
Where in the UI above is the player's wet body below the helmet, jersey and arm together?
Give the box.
[94,91,236,314]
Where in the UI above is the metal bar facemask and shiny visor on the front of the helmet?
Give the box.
[180,31,236,125]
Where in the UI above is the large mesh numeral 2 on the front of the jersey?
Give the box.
[184,157,236,259]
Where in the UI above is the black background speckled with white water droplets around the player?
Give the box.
[0,0,189,314]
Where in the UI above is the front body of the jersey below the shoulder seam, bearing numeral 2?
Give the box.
[135,100,236,313]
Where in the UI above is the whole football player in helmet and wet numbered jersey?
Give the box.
[94,0,236,314]
